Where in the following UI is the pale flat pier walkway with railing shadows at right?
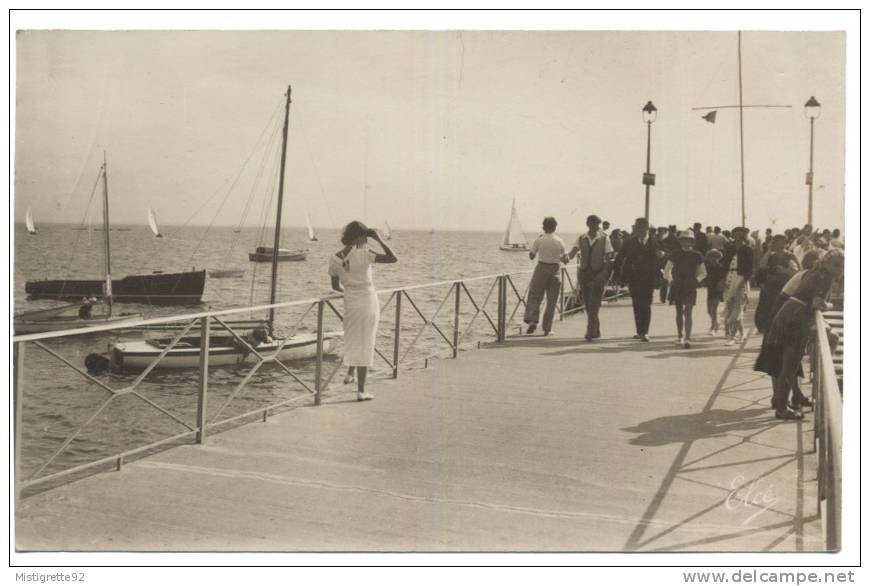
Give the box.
[16,299,824,551]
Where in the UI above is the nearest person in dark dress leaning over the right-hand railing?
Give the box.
[755,249,844,419]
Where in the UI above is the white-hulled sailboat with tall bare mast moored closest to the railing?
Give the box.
[104,86,343,370]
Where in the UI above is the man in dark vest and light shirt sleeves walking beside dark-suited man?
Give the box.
[568,214,613,341]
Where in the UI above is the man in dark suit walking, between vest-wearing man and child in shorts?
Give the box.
[615,218,661,342]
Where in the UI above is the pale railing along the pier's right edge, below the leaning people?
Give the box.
[810,311,843,551]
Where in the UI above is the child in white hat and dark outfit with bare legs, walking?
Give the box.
[665,230,707,348]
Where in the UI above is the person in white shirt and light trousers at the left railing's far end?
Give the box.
[523,217,565,336]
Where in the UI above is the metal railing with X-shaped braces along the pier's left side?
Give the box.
[13,271,540,498]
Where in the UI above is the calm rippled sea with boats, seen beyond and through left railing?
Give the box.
[14,224,576,482]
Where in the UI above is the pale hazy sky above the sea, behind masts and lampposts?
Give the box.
[15,31,845,232]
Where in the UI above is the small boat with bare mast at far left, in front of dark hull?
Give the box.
[12,155,142,334]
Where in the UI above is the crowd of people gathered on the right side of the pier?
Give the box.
[524,214,845,419]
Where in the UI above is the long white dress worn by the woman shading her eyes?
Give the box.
[329,247,381,366]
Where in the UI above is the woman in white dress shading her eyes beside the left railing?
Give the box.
[329,221,398,401]
